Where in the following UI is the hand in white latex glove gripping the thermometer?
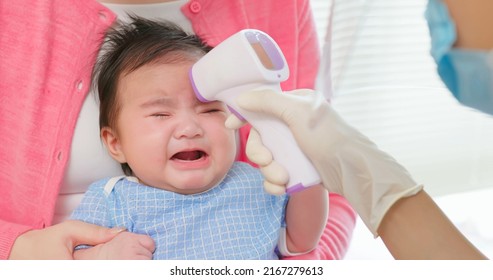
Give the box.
[226,90,423,237]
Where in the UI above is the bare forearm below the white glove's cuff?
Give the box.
[378,191,486,260]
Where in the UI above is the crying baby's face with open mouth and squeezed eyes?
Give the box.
[111,61,236,194]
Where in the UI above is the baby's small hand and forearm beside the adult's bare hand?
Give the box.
[74,232,155,260]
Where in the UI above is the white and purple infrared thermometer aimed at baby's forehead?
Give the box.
[190,29,321,193]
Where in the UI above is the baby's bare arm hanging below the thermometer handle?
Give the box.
[280,185,329,254]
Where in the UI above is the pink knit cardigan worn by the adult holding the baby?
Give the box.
[0,0,356,259]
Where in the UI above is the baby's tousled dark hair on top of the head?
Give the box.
[93,15,212,176]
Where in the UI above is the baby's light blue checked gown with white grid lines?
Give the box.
[71,162,287,260]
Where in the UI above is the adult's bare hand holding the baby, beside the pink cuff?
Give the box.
[9,221,125,260]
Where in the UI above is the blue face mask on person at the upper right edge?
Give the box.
[425,0,493,114]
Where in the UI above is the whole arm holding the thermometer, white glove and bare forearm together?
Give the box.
[226,90,486,259]
